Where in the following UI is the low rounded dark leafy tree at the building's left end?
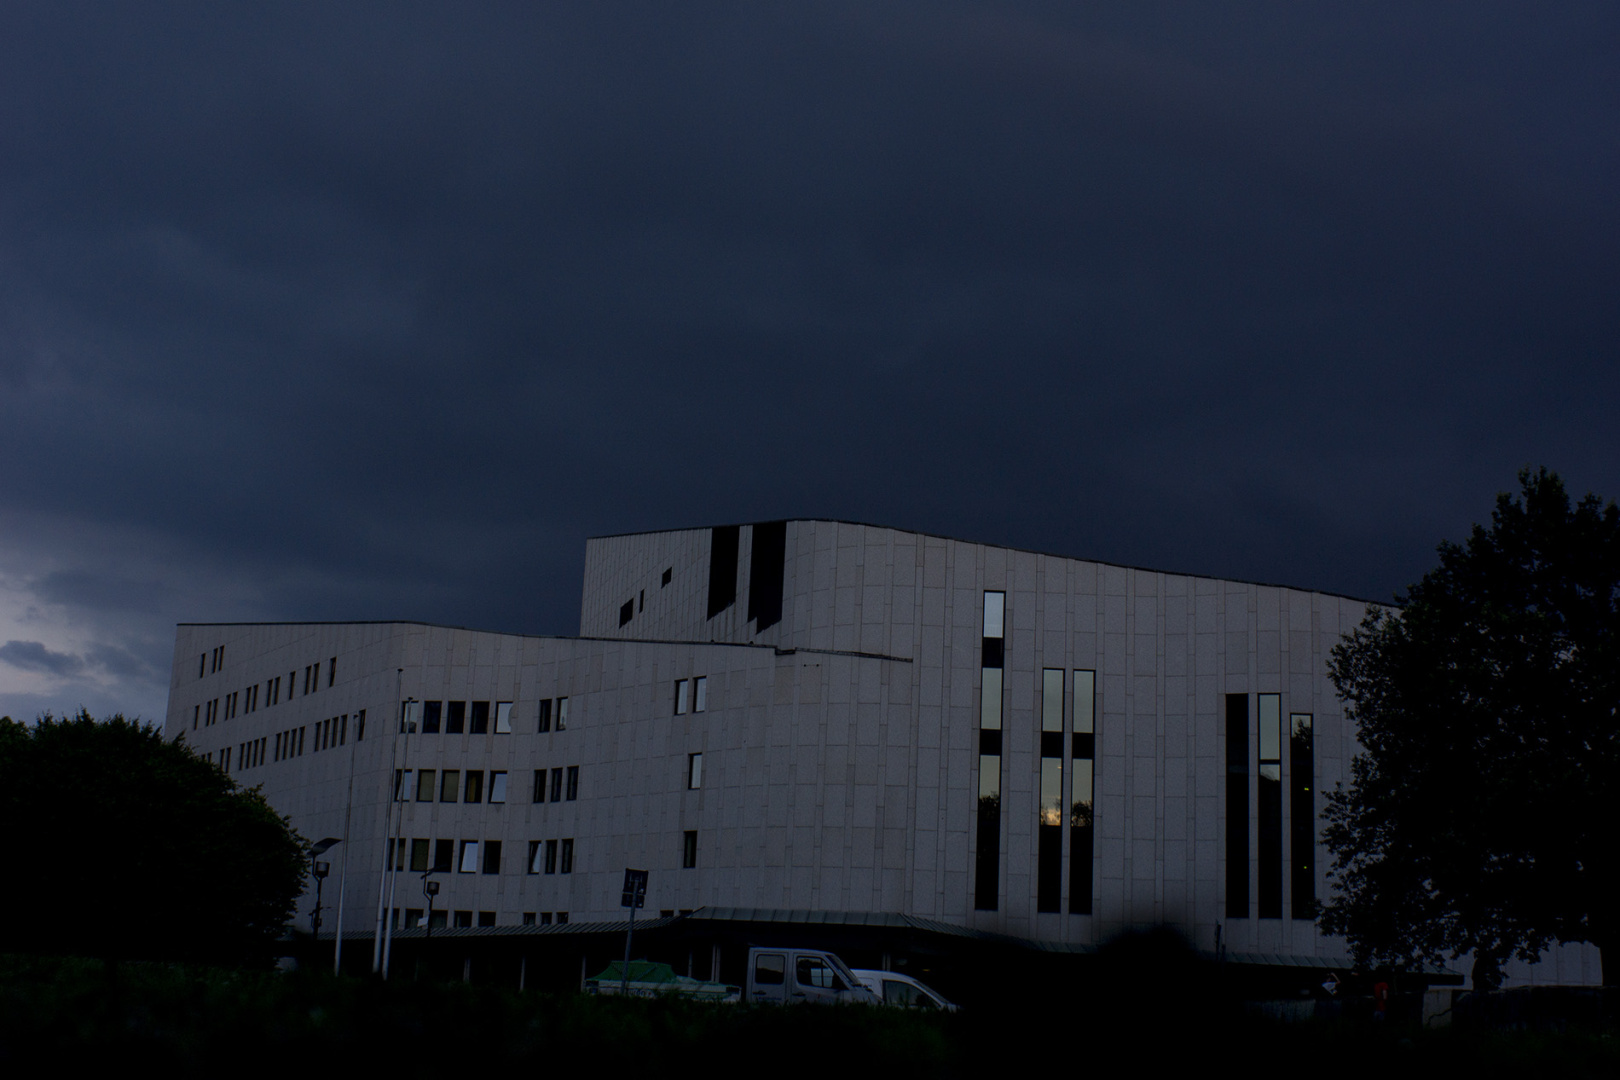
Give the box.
[0,711,308,963]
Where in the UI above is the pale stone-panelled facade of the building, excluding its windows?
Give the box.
[167,520,1425,957]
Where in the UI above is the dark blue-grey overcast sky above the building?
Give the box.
[0,0,1620,719]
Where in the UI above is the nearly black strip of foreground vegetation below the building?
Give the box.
[0,957,1620,1080]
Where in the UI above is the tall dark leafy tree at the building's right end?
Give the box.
[1322,470,1620,988]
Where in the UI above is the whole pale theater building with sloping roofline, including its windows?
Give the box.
[167,520,1581,981]
